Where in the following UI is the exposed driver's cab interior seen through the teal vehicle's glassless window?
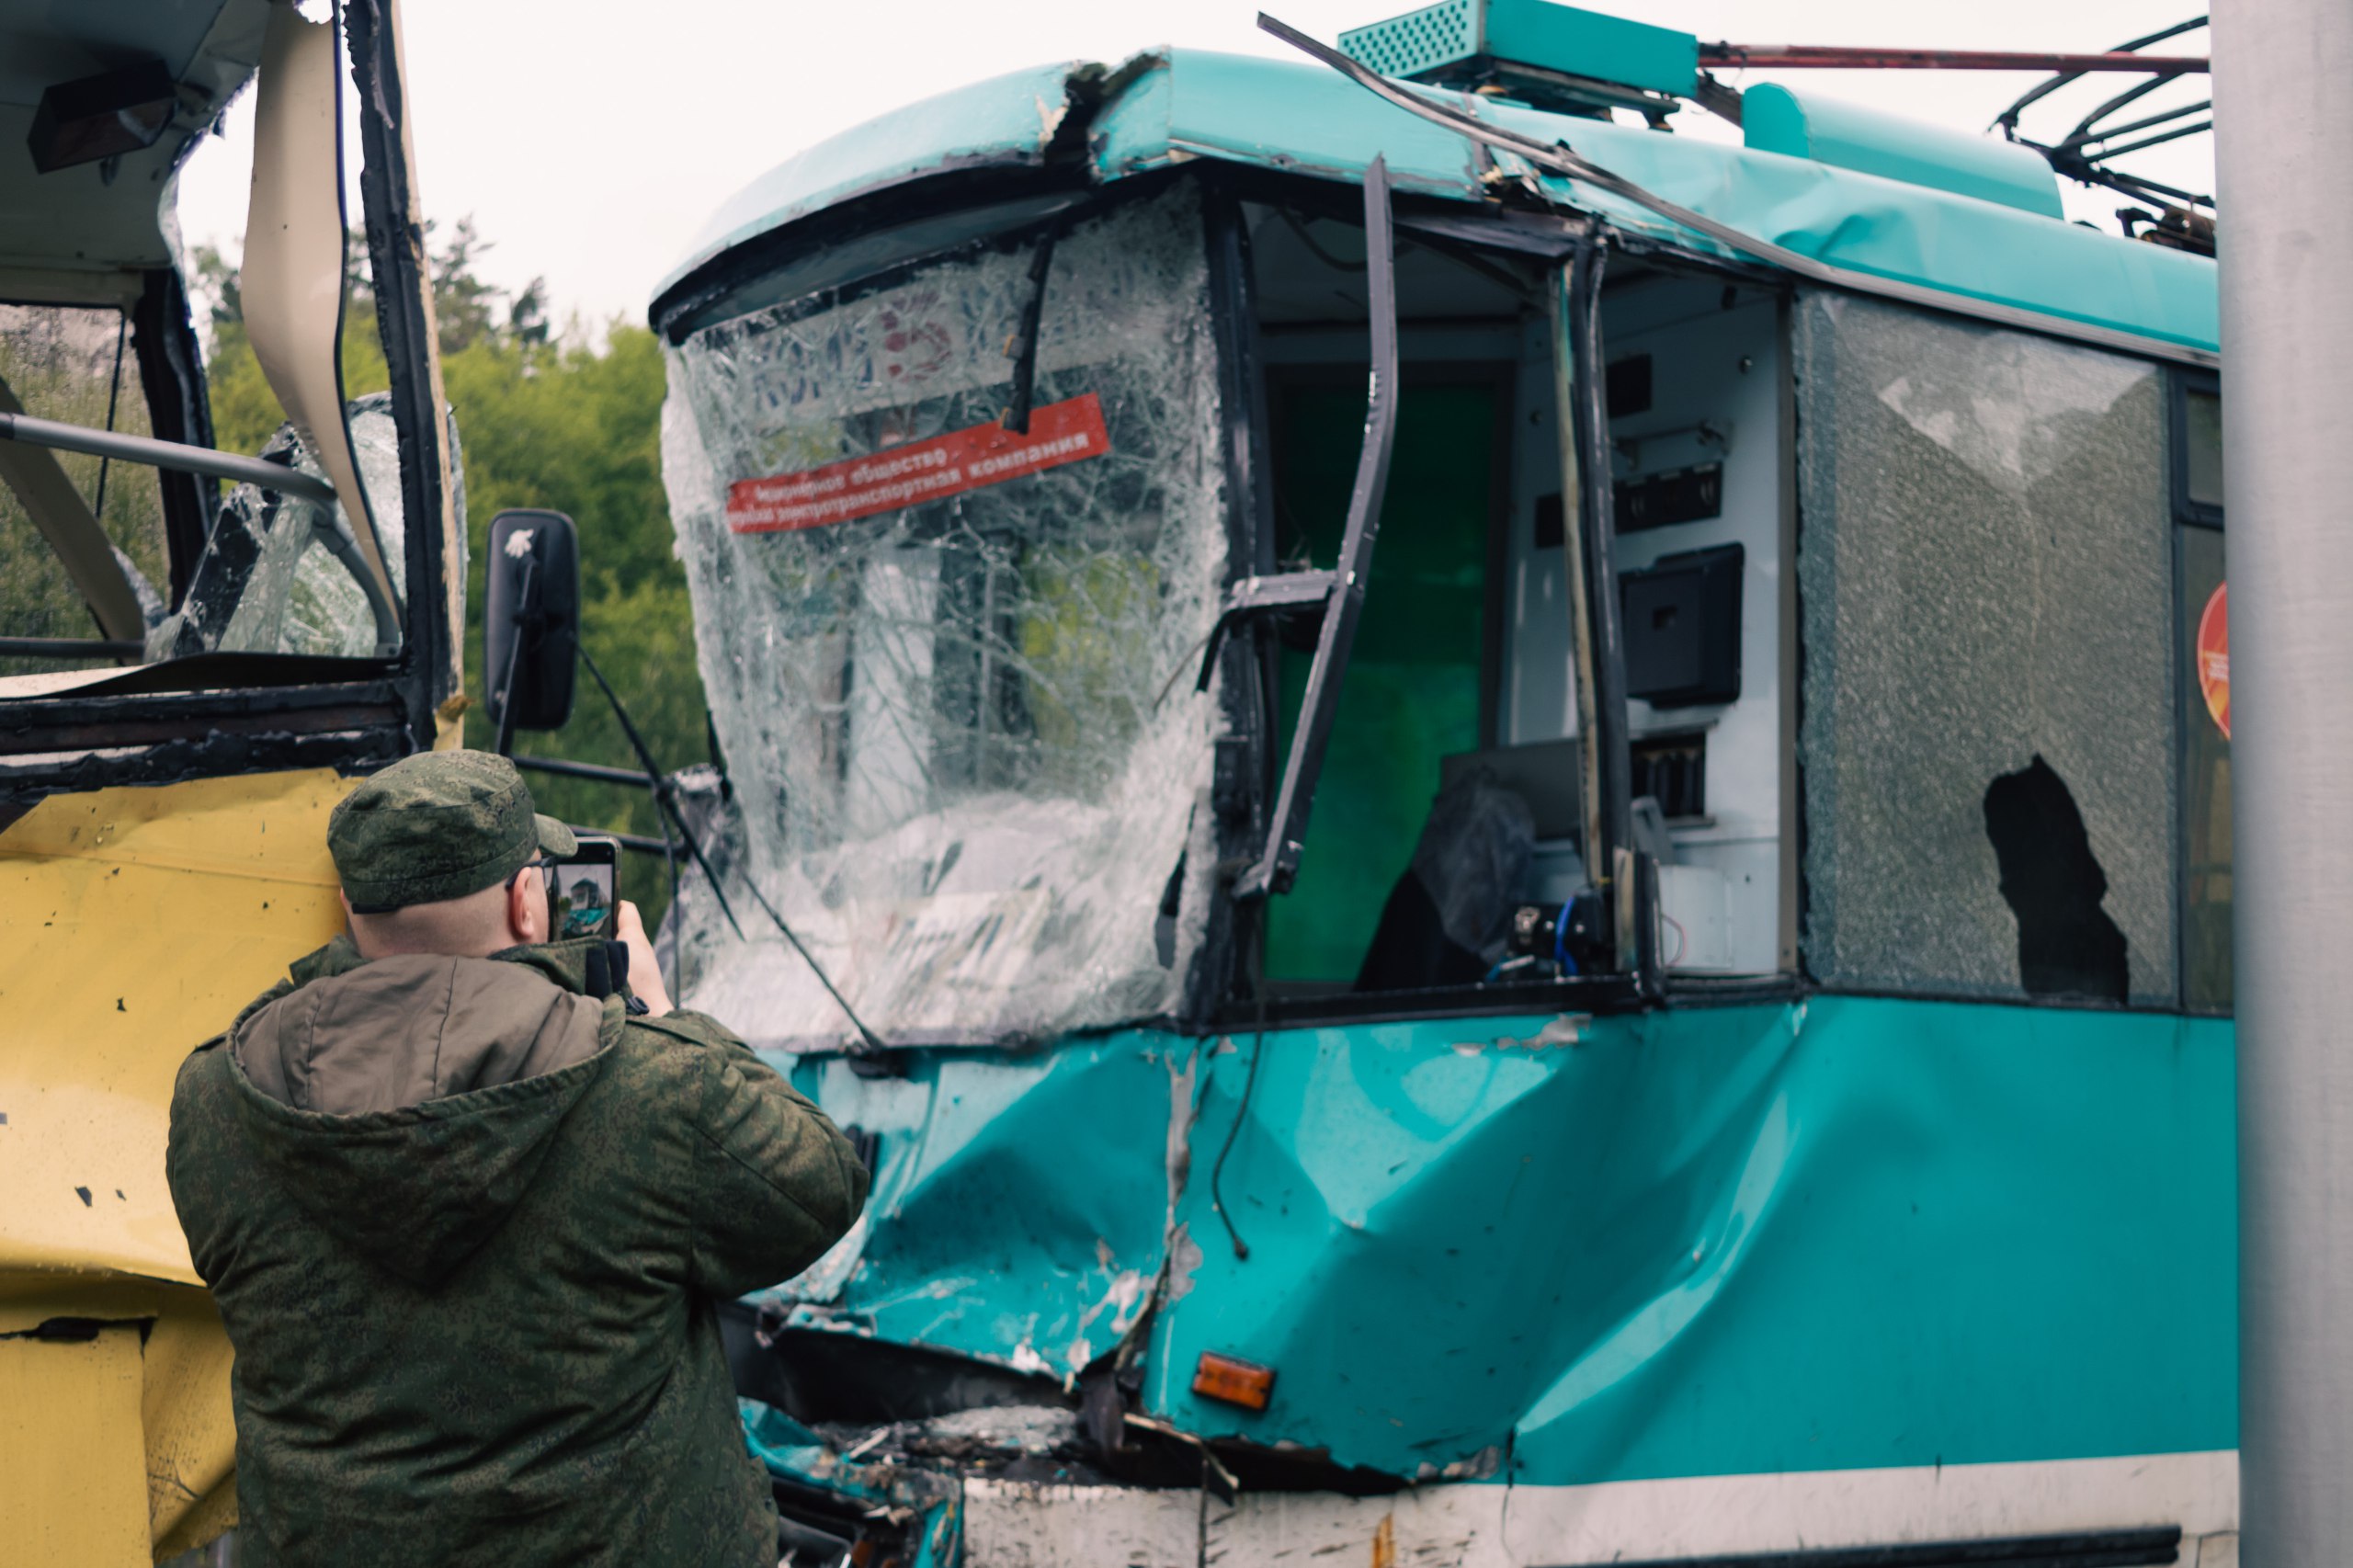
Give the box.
[1247,191,1795,1010]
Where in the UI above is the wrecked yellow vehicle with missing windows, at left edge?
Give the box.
[0,0,466,1568]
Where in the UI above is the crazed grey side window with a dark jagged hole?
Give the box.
[1795,297,2177,1003]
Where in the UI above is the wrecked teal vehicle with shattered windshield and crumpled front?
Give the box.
[616,0,2235,1568]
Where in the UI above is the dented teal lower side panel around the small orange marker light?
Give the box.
[1146,998,2235,1483]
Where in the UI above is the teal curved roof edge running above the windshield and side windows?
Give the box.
[661,50,2222,348]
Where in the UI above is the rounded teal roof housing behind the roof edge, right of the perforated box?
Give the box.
[1741,83,2066,219]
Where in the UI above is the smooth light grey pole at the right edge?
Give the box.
[2214,0,2353,1568]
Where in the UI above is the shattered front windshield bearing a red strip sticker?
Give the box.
[664,190,1226,1043]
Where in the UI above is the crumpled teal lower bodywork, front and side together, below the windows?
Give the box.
[765,996,2235,1487]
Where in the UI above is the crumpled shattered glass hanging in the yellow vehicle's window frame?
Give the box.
[148,393,409,662]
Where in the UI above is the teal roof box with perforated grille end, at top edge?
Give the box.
[1339,0,1699,118]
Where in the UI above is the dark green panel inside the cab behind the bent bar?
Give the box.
[1266,379,1504,982]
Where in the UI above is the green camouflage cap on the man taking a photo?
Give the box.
[327,751,579,914]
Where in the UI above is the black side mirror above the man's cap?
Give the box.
[483,511,581,756]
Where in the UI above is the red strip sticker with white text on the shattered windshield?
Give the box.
[727,393,1110,534]
